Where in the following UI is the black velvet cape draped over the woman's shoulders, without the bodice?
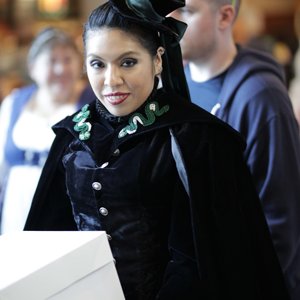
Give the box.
[25,89,289,300]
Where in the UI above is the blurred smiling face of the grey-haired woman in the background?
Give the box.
[30,45,82,99]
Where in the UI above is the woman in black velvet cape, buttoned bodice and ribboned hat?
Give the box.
[25,0,288,300]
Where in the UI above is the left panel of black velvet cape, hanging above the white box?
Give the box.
[24,131,77,230]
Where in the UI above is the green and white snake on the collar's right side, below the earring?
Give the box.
[118,101,170,138]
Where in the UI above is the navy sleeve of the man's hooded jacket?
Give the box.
[246,88,300,276]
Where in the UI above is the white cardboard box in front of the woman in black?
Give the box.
[0,231,125,300]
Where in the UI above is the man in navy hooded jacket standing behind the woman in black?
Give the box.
[173,0,300,300]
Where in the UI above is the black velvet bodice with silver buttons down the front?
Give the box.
[63,98,176,300]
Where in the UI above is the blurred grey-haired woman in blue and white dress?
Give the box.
[0,27,93,233]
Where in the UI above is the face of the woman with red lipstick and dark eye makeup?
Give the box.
[86,28,162,116]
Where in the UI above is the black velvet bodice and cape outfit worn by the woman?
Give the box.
[25,91,289,300]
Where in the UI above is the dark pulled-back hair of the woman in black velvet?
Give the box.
[83,2,160,56]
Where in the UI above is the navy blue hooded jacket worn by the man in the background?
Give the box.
[186,47,300,300]
